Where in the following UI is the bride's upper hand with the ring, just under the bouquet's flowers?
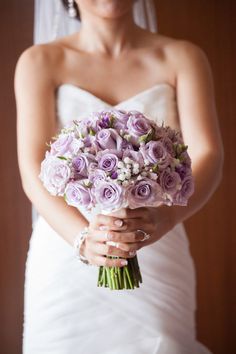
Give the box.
[89,205,174,255]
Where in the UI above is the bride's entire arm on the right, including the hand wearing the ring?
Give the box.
[98,42,223,251]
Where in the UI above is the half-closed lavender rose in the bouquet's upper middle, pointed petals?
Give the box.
[96,128,123,151]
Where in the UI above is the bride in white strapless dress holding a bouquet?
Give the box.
[15,0,223,354]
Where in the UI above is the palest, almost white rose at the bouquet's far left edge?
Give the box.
[39,153,71,196]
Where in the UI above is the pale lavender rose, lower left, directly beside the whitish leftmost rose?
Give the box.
[65,181,92,208]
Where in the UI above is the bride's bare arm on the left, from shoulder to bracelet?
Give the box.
[15,46,88,244]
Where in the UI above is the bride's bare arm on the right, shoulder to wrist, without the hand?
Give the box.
[170,42,224,222]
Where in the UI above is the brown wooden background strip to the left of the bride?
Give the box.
[0,0,33,354]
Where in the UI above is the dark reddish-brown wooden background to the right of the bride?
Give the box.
[155,0,236,354]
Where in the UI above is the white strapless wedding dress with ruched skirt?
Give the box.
[23,84,210,354]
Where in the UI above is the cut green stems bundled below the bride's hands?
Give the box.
[97,256,142,290]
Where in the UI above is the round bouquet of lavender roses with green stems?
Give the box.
[40,109,194,289]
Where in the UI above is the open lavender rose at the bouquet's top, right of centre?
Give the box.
[127,112,152,138]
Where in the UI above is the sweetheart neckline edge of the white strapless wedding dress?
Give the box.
[57,82,175,108]
